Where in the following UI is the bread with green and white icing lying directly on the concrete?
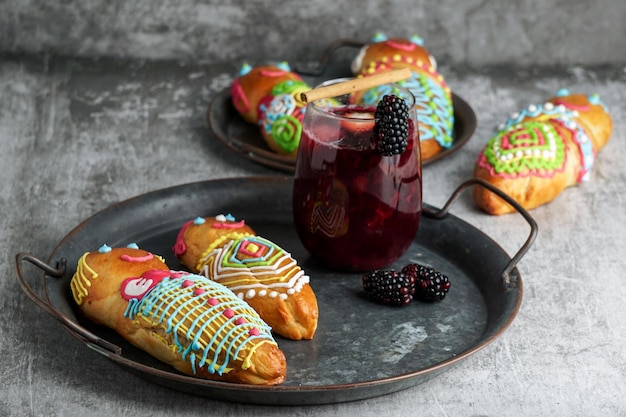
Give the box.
[474,90,613,215]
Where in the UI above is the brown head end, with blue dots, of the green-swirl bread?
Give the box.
[230,62,302,124]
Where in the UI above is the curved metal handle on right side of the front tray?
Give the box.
[423,178,539,289]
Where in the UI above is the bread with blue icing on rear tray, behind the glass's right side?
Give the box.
[351,33,454,160]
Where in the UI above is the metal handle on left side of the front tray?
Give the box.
[15,253,122,355]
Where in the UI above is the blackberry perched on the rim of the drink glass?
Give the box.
[373,94,409,156]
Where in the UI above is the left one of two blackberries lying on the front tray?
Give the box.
[363,270,413,306]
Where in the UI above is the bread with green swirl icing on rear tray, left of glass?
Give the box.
[230,62,310,158]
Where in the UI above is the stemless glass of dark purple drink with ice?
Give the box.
[293,80,422,271]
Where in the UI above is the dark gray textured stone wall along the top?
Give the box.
[0,0,626,67]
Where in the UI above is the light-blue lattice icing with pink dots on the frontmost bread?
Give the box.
[124,274,274,375]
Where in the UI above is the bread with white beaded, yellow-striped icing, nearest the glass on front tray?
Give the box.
[174,215,319,340]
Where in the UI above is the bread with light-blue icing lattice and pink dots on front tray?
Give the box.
[70,245,287,385]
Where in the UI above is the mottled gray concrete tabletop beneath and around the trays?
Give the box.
[0,52,626,417]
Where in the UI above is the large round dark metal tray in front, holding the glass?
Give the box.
[16,177,536,405]
